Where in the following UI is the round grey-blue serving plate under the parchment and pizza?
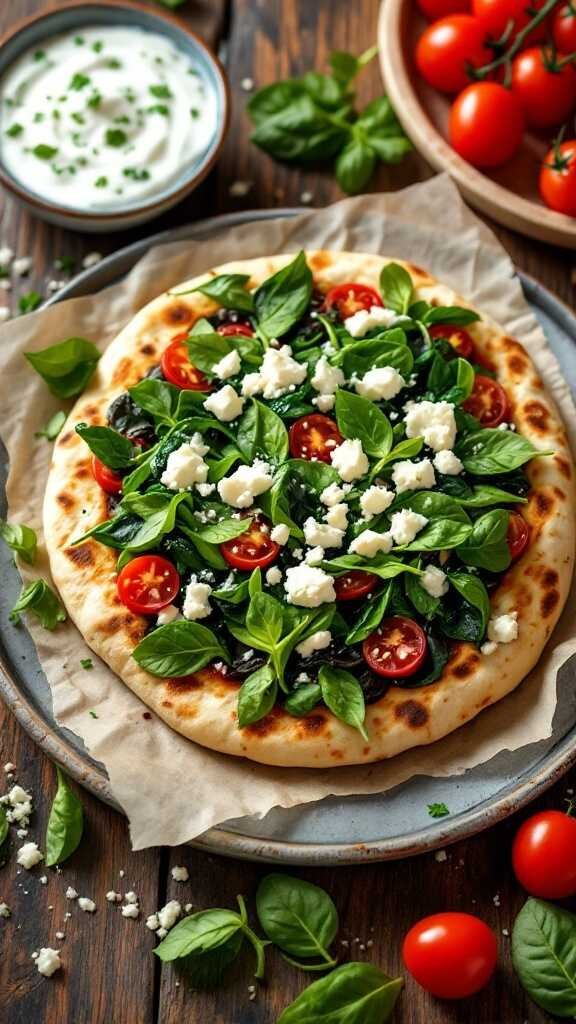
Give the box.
[0,209,576,864]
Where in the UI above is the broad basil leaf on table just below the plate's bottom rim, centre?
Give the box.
[256,874,338,970]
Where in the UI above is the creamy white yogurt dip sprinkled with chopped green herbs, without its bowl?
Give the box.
[0,26,217,211]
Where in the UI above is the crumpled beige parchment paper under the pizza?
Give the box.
[0,176,576,849]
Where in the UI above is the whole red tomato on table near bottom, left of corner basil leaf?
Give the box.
[402,912,498,999]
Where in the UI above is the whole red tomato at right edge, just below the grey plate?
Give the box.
[512,811,576,899]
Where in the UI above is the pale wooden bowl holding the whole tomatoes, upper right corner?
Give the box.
[378,0,576,249]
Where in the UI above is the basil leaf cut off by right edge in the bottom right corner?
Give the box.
[511,899,576,1019]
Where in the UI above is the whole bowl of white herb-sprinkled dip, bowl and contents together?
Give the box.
[0,0,229,231]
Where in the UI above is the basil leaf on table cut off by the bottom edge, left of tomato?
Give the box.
[276,962,403,1024]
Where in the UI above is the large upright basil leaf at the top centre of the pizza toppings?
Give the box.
[254,251,313,338]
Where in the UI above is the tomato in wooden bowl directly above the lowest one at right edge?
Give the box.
[512,46,576,127]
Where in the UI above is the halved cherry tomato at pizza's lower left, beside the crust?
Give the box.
[116,555,180,615]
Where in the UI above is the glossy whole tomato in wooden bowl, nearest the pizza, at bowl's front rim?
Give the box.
[448,82,524,167]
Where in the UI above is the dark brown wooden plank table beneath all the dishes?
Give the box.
[0,0,576,1024]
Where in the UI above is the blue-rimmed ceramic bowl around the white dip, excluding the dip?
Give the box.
[0,0,230,232]
